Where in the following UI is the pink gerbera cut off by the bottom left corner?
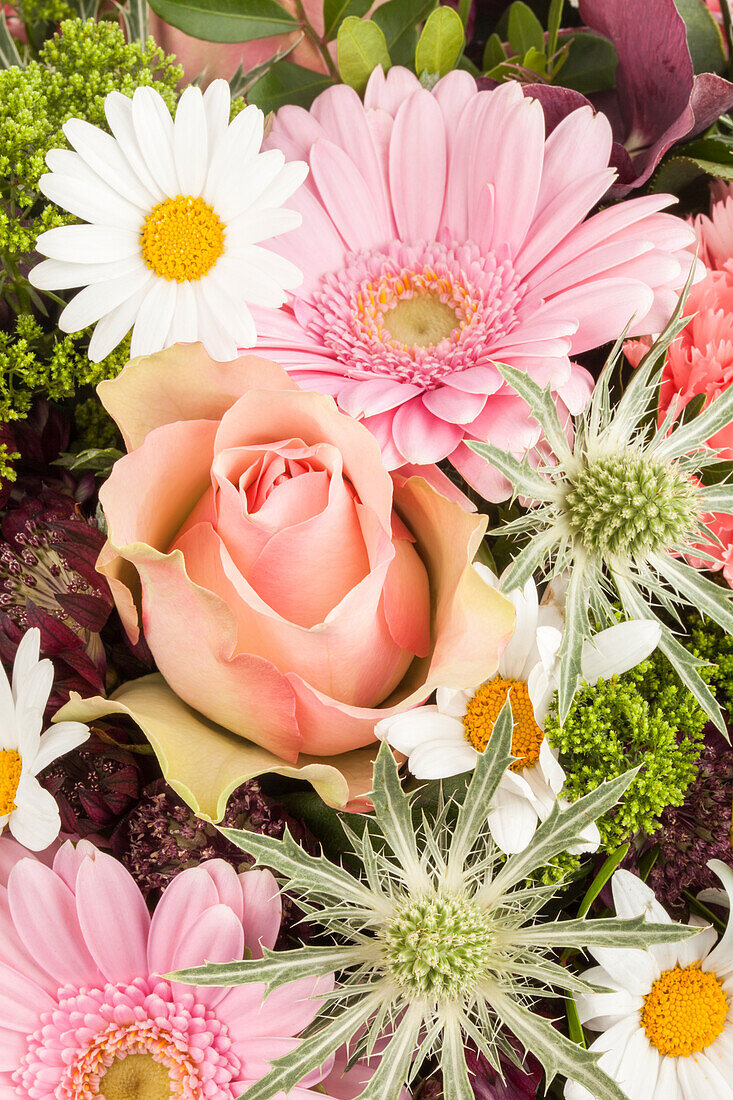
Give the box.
[0,839,352,1100]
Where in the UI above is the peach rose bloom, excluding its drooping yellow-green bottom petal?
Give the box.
[94,344,513,761]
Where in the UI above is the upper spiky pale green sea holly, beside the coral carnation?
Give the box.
[469,295,733,733]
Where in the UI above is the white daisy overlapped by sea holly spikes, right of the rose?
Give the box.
[375,565,660,855]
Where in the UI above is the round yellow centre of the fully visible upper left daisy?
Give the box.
[140,195,226,283]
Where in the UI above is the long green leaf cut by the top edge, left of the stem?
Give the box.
[151,0,298,42]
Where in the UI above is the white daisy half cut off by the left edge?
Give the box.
[0,628,89,851]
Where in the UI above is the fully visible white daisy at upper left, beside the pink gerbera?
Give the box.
[29,80,308,363]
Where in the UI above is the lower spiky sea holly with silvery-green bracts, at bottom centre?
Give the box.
[175,704,697,1100]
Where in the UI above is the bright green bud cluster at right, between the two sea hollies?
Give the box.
[545,651,708,851]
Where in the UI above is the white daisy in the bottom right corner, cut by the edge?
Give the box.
[565,859,733,1100]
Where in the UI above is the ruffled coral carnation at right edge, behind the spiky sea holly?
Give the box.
[624,267,733,587]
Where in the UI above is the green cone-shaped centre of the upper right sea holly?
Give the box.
[565,452,700,558]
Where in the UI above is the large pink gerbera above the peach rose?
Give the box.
[250,67,693,499]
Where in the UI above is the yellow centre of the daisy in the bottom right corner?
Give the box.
[642,963,727,1058]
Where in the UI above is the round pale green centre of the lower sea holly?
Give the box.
[381,894,492,1001]
